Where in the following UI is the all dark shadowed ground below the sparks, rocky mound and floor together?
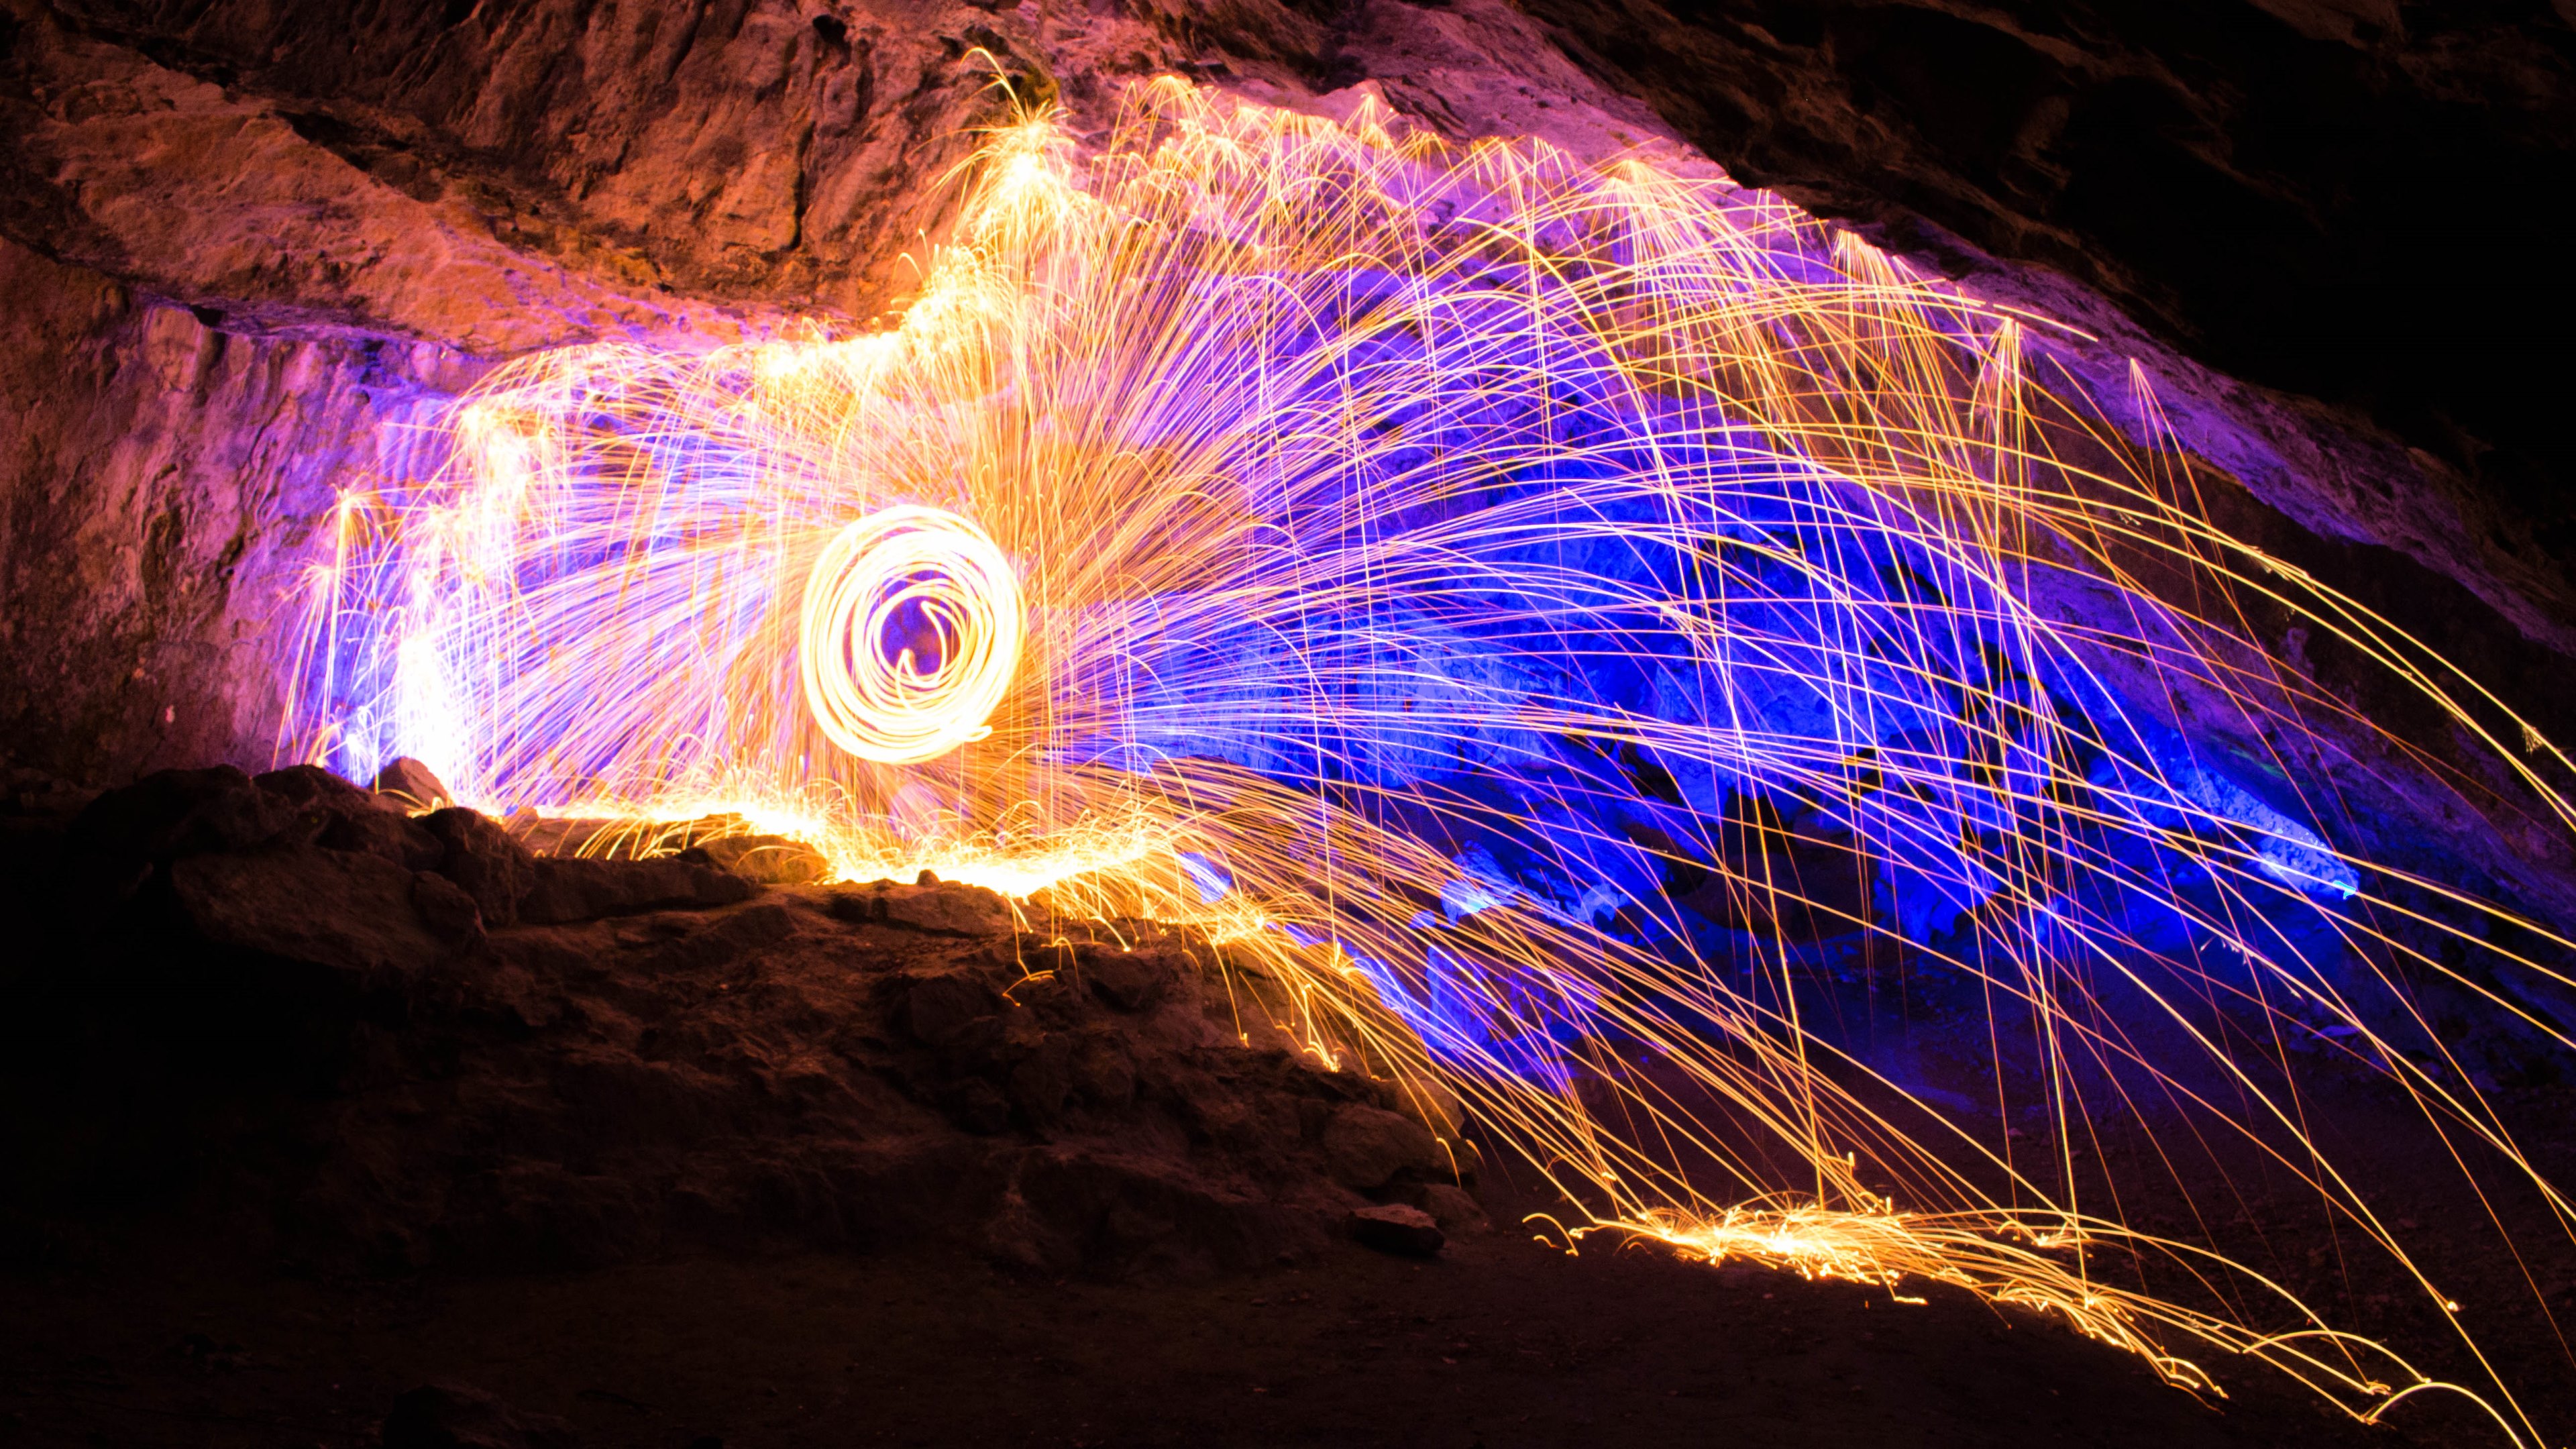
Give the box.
[0,768,2576,1449]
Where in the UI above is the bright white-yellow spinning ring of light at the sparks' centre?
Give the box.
[798,505,1025,765]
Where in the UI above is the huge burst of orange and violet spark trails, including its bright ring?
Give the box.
[297,83,2576,1434]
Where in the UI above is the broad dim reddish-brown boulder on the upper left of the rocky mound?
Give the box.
[170,846,453,977]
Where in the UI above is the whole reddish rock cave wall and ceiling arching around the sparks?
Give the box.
[0,0,2576,799]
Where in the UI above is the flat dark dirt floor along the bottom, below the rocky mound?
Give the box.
[0,1201,2502,1449]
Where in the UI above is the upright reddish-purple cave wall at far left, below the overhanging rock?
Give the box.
[0,242,474,779]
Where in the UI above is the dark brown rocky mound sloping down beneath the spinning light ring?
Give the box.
[0,768,1476,1273]
